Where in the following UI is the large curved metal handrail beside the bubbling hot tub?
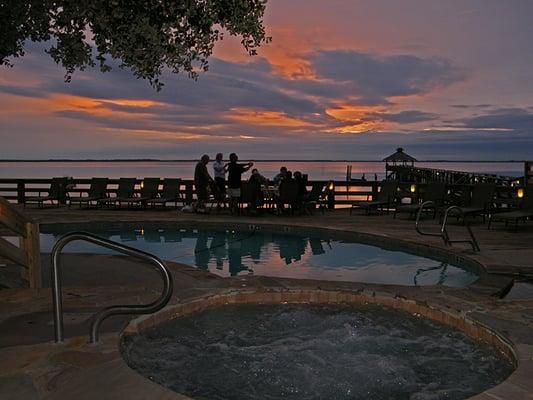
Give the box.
[50,232,173,343]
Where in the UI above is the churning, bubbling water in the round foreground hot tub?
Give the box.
[122,305,513,400]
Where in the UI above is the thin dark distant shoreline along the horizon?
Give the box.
[0,158,527,163]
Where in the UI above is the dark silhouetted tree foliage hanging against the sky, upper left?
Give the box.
[0,0,270,90]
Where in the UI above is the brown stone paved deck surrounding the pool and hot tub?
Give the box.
[0,208,533,400]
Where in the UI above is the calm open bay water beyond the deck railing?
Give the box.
[0,160,524,180]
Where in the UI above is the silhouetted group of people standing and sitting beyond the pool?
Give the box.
[194,153,307,213]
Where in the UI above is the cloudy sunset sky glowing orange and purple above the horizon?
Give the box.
[0,0,533,160]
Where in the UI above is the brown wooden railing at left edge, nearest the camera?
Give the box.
[0,197,42,289]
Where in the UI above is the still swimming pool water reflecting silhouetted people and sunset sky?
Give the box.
[41,224,477,287]
